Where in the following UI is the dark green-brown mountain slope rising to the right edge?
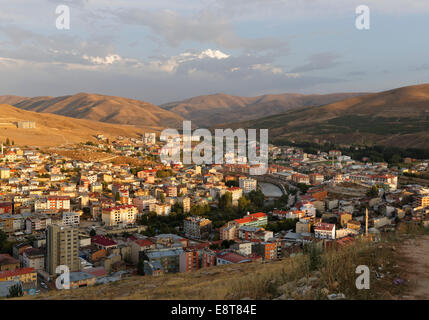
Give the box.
[223,84,429,148]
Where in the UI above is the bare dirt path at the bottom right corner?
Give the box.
[398,235,429,300]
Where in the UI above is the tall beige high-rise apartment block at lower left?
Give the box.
[46,225,80,275]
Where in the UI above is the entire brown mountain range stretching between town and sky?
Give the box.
[0,84,429,148]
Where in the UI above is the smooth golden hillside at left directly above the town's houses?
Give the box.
[0,104,160,146]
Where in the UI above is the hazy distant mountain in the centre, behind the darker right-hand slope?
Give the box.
[161,93,362,127]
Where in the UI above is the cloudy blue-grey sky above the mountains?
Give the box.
[0,0,429,104]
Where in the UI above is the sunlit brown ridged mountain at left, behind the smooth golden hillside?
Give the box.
[0,93,183,128]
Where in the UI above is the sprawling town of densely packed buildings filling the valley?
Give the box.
[0,133,429,297]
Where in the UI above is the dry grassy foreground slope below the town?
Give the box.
[27,228,429,300]
